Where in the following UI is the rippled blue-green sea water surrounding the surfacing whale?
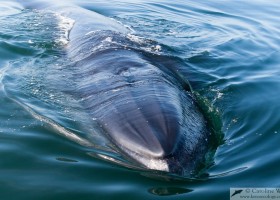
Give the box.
[0,0,280,200]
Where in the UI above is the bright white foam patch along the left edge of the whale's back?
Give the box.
[55,13,75,45]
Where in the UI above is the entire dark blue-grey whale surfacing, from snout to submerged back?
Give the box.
[18,1,214,175]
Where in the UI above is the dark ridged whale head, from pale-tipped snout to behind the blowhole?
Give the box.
[75,49,208,174]
